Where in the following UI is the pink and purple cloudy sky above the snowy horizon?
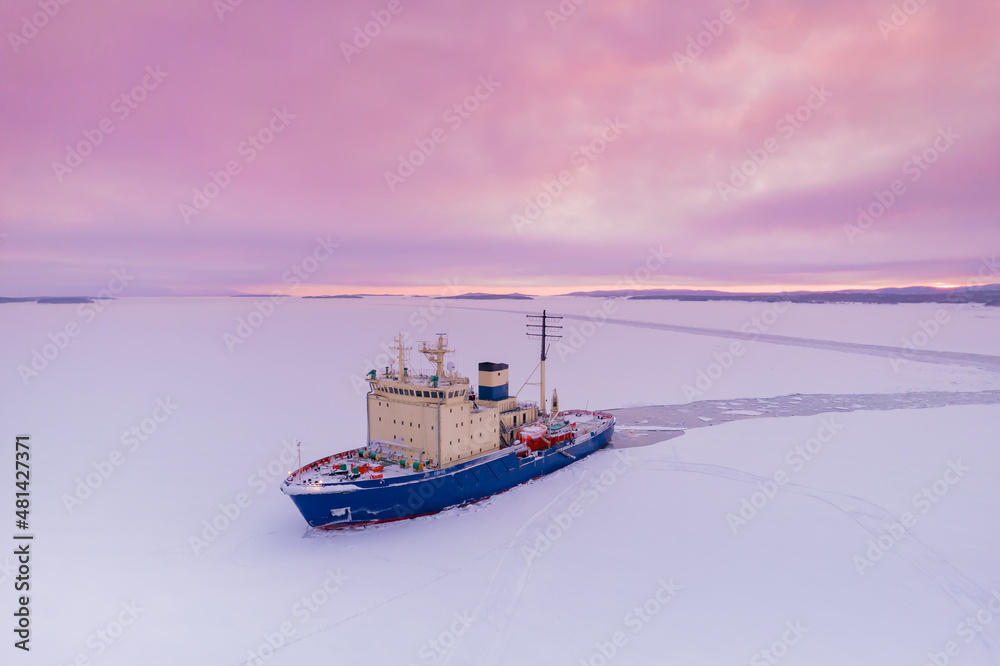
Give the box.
[0,0,1000,296]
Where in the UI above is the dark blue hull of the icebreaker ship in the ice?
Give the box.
[285,418,615,528]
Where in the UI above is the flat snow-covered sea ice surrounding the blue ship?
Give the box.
[0,298,1000,666]
